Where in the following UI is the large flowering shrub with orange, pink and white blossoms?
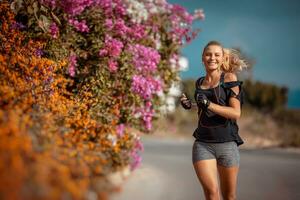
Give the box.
[0,0,203,199]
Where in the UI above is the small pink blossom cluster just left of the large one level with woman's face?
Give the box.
[99,35,124,58]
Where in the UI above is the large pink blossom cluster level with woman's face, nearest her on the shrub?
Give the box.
[128,44,160,74]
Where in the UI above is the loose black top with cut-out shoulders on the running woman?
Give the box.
[193,73,244,145]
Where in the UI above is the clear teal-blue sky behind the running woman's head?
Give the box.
[168,0,300,90]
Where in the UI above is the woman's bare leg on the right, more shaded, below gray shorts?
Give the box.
[218,165,239,200]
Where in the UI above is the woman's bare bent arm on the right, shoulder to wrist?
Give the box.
[207,73,241,120]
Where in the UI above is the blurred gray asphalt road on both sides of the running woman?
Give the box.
[112,138,300,200]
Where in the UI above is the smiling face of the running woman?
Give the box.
[202,45,223,71]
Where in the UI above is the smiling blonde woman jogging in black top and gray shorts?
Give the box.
[180,41,246,200]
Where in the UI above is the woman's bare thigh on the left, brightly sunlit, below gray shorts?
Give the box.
[194,159,220,200]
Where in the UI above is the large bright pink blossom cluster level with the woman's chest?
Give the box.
[131,75,162,100]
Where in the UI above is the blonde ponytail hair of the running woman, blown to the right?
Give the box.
[202,41,248,73]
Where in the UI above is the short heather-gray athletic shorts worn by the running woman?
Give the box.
[193,140,240,167]
